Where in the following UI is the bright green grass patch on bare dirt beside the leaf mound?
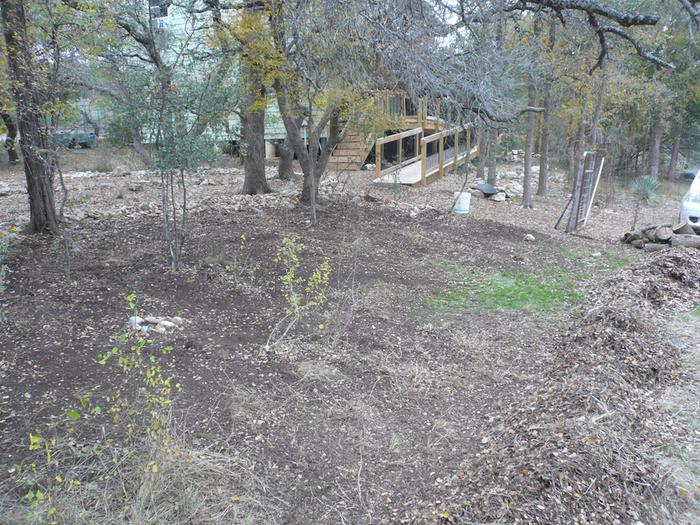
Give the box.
[428,272,582,312]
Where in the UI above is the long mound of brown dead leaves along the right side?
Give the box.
[449,248,700,525]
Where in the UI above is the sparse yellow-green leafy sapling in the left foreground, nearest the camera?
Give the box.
[13,294,180,525]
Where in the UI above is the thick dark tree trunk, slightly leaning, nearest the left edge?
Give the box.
[1,0,58,233]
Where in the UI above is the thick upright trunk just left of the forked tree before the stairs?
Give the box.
[241,59,272,195]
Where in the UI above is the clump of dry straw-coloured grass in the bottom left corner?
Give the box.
[0,414,286,525]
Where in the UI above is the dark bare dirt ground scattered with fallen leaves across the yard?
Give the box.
[0,148,700,525]
